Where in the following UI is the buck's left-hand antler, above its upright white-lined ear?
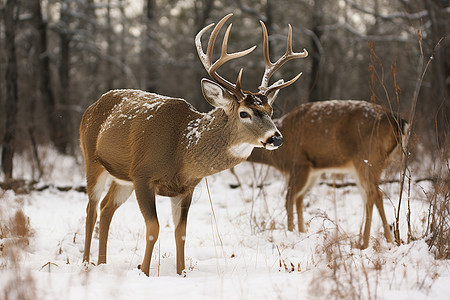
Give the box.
[195,14,256,101]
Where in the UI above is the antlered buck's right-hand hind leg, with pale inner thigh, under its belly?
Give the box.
[98,181,133,264]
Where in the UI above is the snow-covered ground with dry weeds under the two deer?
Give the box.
[0,152,450,300]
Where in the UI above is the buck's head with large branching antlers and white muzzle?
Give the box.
[195,14,308,152]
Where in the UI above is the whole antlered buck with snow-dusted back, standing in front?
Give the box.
[80,14,308,276]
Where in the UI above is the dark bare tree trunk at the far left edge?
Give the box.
[2,0,19,181]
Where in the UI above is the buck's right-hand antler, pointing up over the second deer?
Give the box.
[259,21,308,95]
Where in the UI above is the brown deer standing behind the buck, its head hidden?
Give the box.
[247,100,407,249]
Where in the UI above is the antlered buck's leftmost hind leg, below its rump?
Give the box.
[83,164,108,262]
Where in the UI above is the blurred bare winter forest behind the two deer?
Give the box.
[0,0,450,176]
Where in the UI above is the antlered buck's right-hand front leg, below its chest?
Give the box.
[172,193,192,275]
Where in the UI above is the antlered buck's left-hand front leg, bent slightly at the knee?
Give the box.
[134,180,159,276]
